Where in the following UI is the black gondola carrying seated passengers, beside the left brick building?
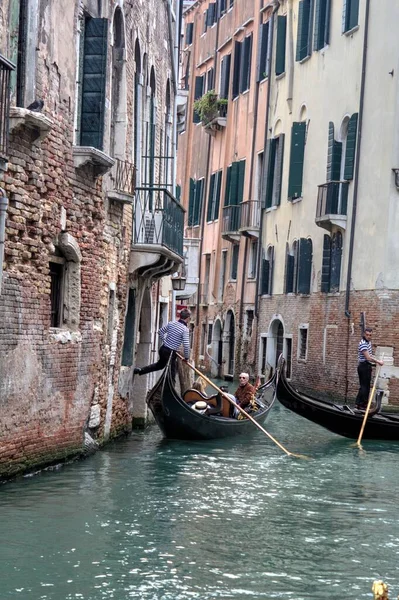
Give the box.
[147,366,275,440]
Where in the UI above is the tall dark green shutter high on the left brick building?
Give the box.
[80,18,108,150]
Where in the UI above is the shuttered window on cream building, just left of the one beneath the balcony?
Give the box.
[285,238,313,295]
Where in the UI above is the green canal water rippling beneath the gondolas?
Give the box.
[0,406,399,600]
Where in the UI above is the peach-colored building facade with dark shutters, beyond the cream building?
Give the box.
[177,0,272,377]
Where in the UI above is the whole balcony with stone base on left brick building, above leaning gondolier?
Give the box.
[130,186,185,278]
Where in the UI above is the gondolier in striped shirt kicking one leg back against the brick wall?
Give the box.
[134,308,191,381]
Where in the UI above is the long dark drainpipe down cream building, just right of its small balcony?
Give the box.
[345,0,370,319]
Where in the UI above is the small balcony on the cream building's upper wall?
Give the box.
[315,181,349,231]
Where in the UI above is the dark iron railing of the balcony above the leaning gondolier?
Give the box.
[133,187,185,257]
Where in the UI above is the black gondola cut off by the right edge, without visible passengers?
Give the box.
[276,357,399,441]
